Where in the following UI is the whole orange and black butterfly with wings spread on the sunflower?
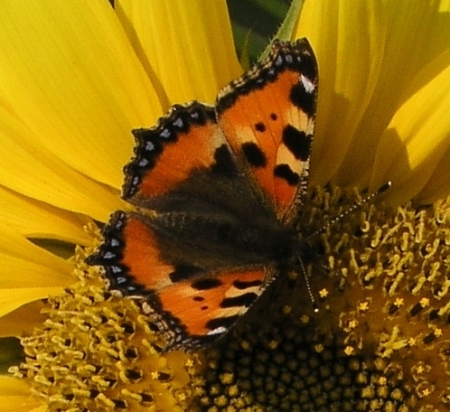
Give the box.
[87,39,318,351]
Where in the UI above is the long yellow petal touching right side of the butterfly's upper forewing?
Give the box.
[294,0,385,185]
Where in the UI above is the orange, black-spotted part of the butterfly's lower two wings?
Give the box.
[90,212,269,350]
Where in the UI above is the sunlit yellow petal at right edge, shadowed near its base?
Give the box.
[372,50,450,203]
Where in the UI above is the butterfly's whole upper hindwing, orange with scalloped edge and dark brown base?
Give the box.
[122,102,274,224]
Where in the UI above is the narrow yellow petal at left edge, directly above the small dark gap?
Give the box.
[0,186,92,245]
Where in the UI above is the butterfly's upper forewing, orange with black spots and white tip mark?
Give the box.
[216,39,318,221]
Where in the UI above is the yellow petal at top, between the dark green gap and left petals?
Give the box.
[115,0,241,108]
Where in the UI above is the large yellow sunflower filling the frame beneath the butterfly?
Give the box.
[0,0,450,412]
